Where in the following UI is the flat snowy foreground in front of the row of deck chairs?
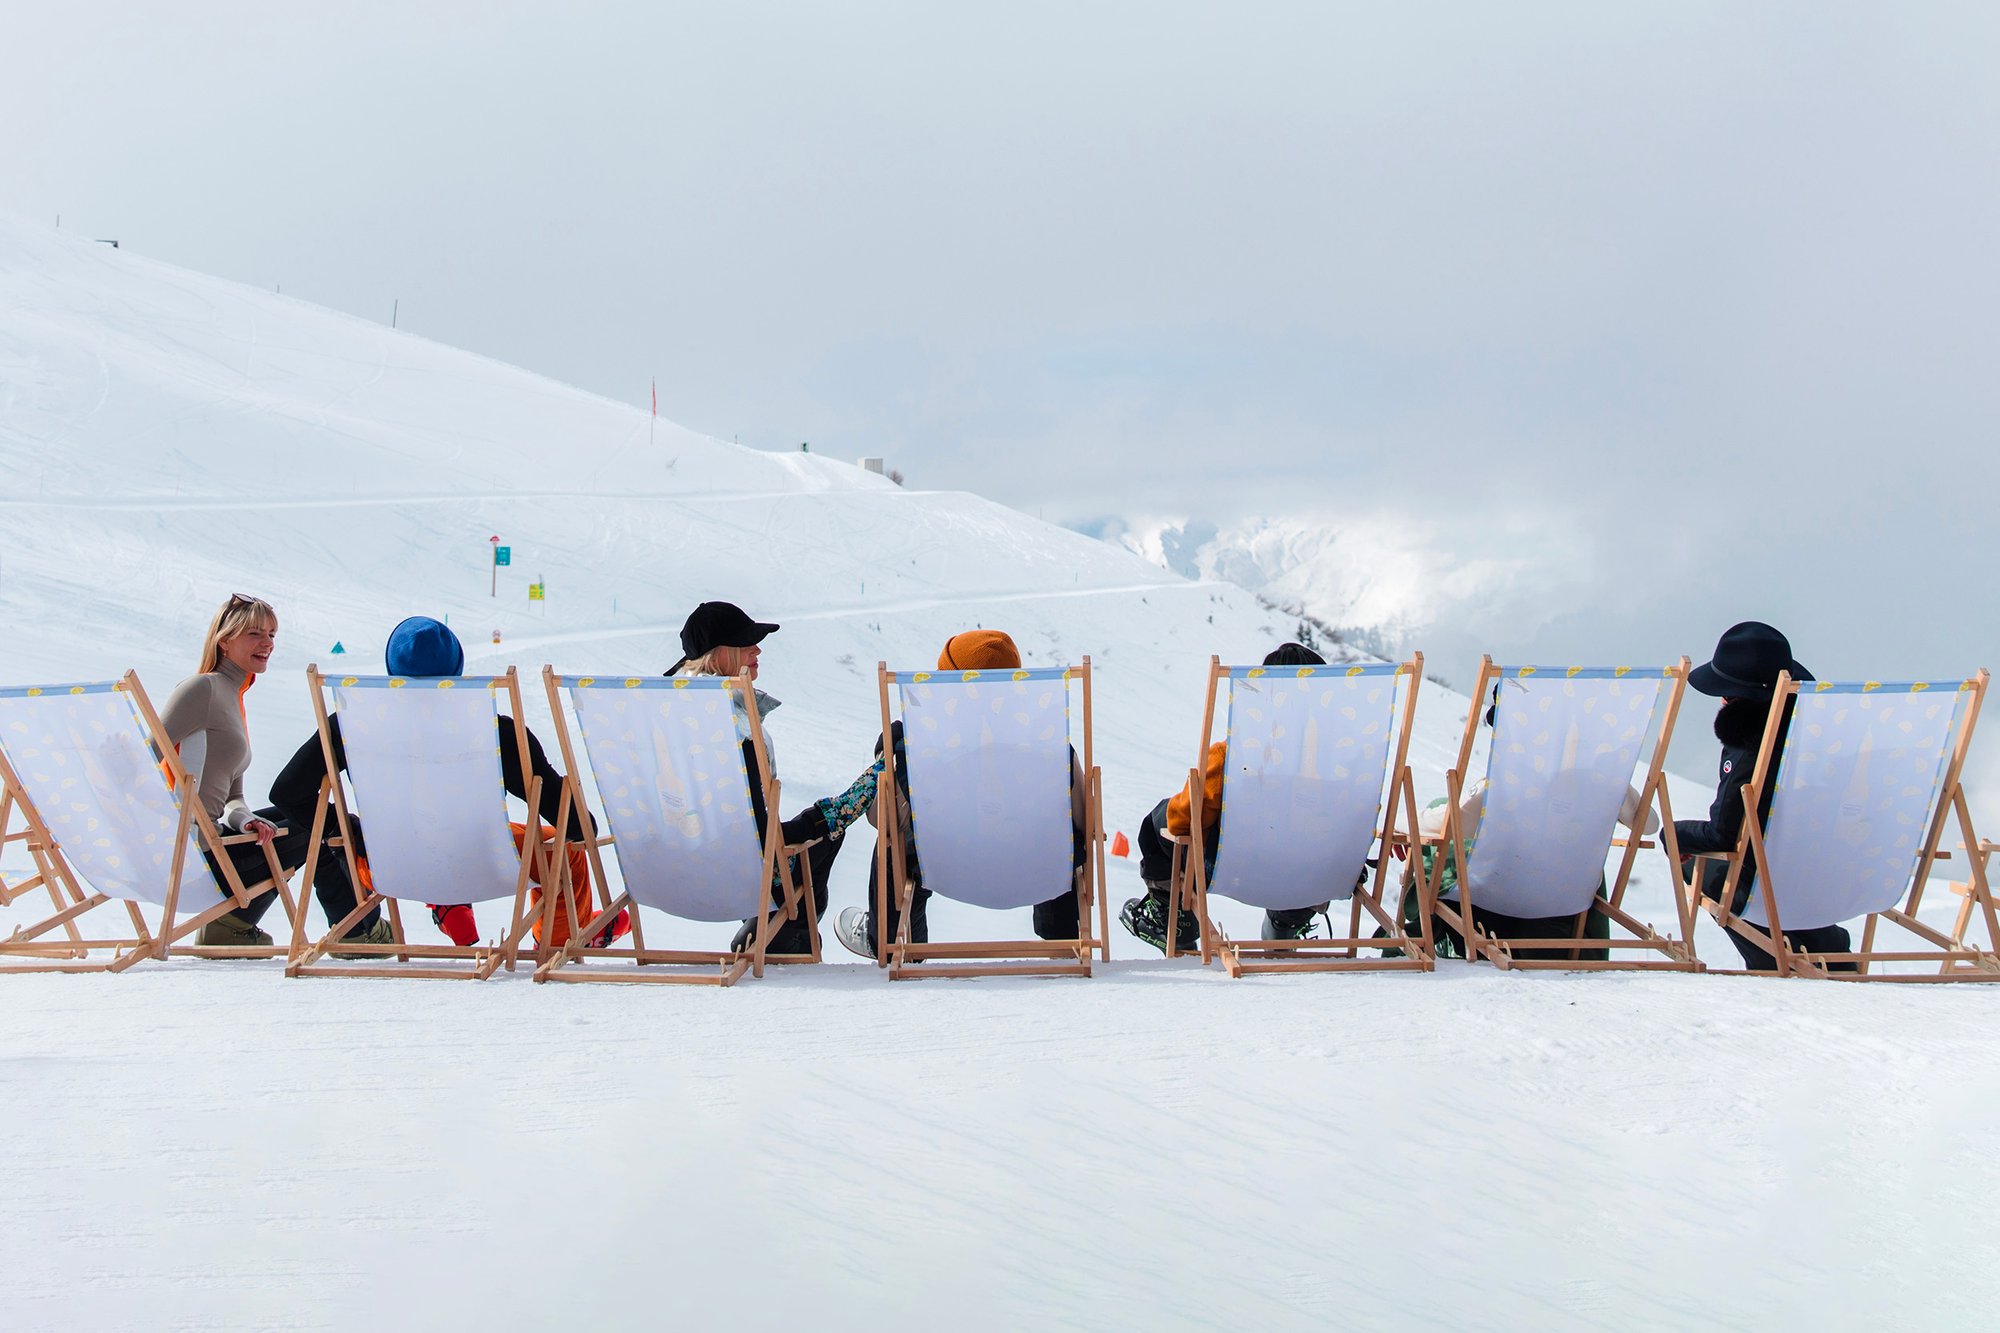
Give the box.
[0,961,2000,1329]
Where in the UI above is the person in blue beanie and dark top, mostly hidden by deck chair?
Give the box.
[270,616,630,945]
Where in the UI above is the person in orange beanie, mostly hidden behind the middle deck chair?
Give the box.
[784,628,1086,959]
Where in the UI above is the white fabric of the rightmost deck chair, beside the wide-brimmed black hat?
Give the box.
[1742,681,1972,931]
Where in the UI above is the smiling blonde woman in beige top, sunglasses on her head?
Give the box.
[160,592,388,945]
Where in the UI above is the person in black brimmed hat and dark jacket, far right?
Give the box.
[1674,620,1854,973]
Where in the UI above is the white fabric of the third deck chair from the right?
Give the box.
[1208,662,1402,911]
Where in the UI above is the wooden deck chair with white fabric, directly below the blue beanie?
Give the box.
[284,667,560,981]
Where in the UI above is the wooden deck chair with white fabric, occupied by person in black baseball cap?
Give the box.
[534,667,820,987]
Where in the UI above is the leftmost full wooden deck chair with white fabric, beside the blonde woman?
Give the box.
[0,673,298,973]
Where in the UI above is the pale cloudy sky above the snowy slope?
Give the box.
[0,0,2000,780]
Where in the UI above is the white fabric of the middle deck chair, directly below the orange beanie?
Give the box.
[896,669,1074,909]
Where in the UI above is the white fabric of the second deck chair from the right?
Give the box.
[1466,667,1666,917]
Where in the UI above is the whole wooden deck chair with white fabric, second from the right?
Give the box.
[1412,656,1702,971]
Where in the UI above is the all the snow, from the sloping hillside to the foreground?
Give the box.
[0,218,2000,1329]
